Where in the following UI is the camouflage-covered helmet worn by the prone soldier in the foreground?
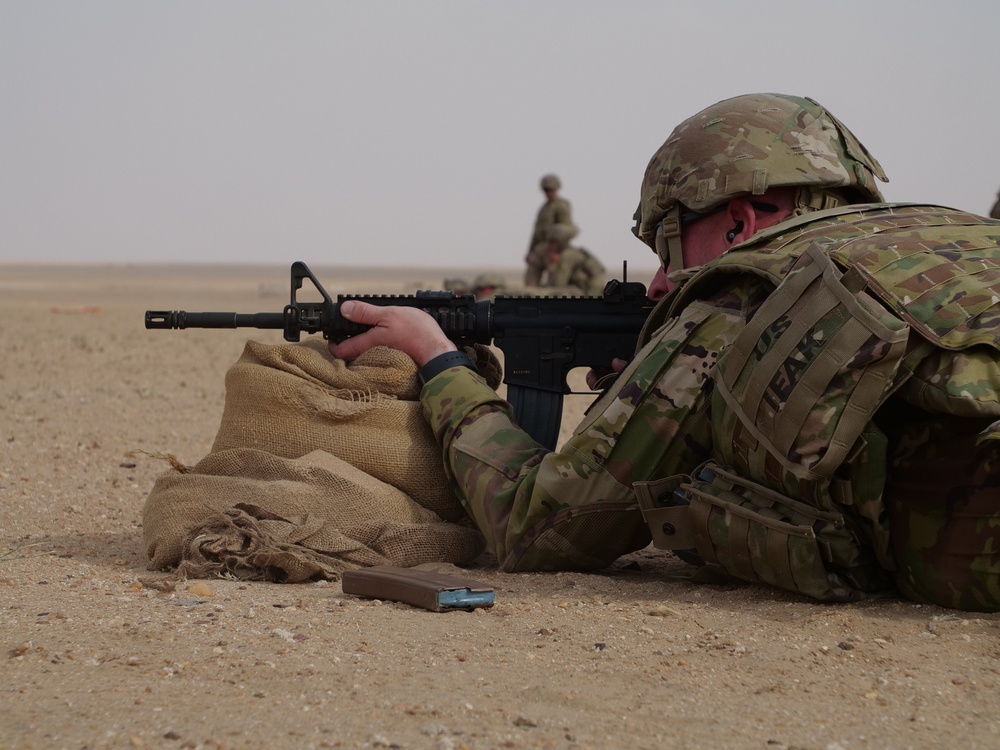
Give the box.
[632,94,889,271]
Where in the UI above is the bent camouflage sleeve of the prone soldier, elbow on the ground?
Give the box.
[421,290,742,571]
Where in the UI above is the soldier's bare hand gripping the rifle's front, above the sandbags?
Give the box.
[329,300,457,367]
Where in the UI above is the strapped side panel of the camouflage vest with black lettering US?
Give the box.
[712,246,908,479]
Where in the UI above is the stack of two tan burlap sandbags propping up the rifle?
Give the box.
[143,340,499,581]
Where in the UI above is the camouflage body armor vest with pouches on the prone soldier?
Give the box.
[636,204,1000,600]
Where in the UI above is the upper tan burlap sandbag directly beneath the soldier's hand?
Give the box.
[212,339,465,520]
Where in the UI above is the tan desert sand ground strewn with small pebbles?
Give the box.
[0,264,1000,750]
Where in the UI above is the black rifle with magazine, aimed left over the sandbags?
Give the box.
[146,261,653,449]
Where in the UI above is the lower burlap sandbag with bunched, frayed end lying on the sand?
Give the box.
[143,448,484,581]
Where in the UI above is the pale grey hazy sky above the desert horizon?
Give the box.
[0,0,1000,273]
